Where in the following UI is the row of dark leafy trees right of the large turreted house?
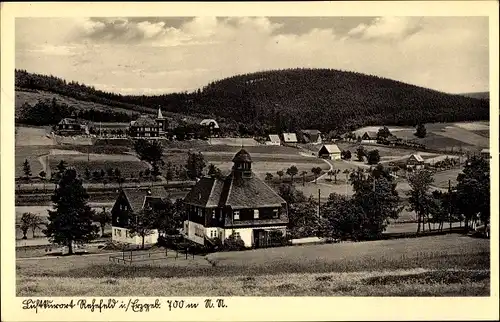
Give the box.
[278,156,490,240]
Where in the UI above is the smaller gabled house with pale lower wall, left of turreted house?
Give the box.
[111,187,168,245]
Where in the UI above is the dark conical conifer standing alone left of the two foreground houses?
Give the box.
[44,169,98,255]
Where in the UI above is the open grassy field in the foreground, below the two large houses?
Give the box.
[16,235,489,296]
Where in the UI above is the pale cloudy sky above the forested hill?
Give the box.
[15,16,489,95]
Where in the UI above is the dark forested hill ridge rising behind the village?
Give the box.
[16,69,489,132]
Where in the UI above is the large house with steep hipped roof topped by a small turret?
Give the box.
[184,149,288,247]
